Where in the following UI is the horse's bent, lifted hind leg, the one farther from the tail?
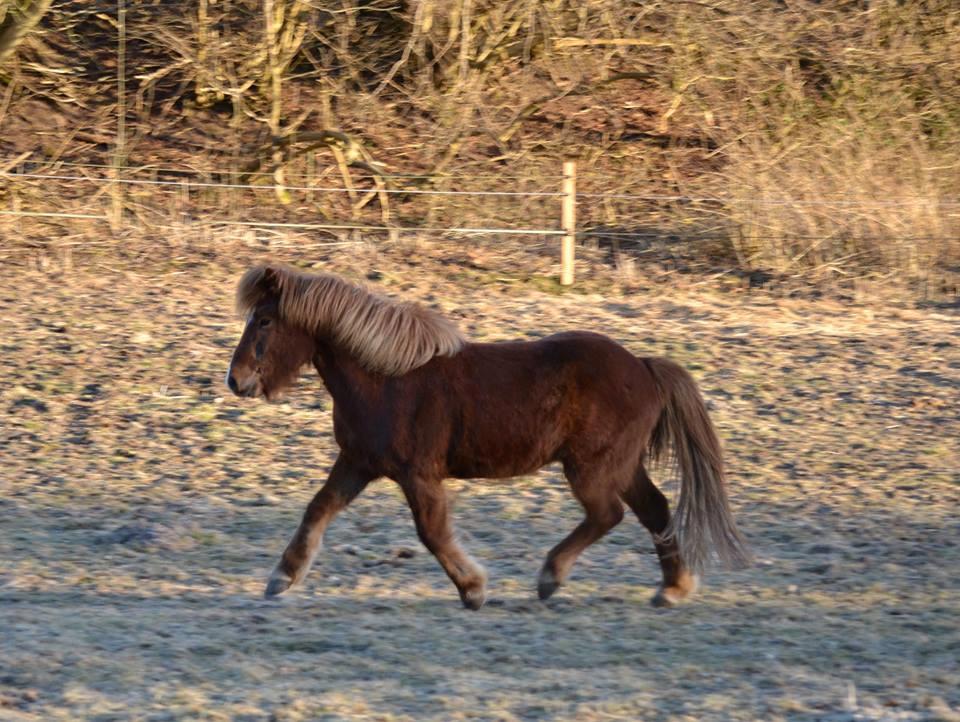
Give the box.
[537,466,623,599]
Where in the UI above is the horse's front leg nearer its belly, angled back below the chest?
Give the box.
[400,480,487,609]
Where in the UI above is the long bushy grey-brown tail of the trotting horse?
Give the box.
[646,358,750,572]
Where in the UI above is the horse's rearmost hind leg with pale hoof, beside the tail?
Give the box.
[623,464,697,607]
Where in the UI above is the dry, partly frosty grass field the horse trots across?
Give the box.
[0,240,960,722]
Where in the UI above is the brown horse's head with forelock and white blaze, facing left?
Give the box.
[226,266,315,400]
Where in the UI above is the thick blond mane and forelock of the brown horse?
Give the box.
[237,266,466,376]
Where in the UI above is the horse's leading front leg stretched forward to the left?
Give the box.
[264,455,373,597]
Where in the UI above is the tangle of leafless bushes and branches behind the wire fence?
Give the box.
[0,0,960,296]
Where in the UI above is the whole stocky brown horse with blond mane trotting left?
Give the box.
[227,266,748,609]
